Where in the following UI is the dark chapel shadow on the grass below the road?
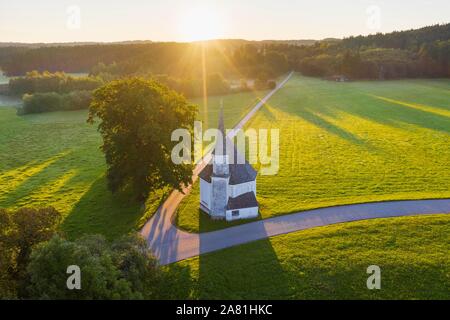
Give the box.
[196,215,291,299]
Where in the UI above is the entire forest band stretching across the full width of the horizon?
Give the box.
[0,24,450,84]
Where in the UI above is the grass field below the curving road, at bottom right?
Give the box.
[167,215,450,299]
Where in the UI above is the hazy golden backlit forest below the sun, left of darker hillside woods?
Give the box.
[0,40,289,79]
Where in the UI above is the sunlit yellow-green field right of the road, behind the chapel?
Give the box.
[177,75,450,232]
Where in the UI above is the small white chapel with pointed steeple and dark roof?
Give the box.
[199,104,259,221]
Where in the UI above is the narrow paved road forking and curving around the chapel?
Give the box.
[141,73,450,265]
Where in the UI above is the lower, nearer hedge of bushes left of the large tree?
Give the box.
[18,91,92,114]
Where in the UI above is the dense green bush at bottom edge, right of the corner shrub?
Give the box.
[27,235,164,299]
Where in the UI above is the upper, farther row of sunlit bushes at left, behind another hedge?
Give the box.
[9,71,103,95]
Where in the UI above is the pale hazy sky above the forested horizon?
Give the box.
[0,0,450,42]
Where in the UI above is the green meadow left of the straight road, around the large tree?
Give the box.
[0,89,268,238]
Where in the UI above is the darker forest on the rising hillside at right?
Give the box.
[297,24,450,79]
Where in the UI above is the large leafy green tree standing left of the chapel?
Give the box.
[88,78,197,199]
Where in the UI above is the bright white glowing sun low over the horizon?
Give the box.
[180,7,223,41]
